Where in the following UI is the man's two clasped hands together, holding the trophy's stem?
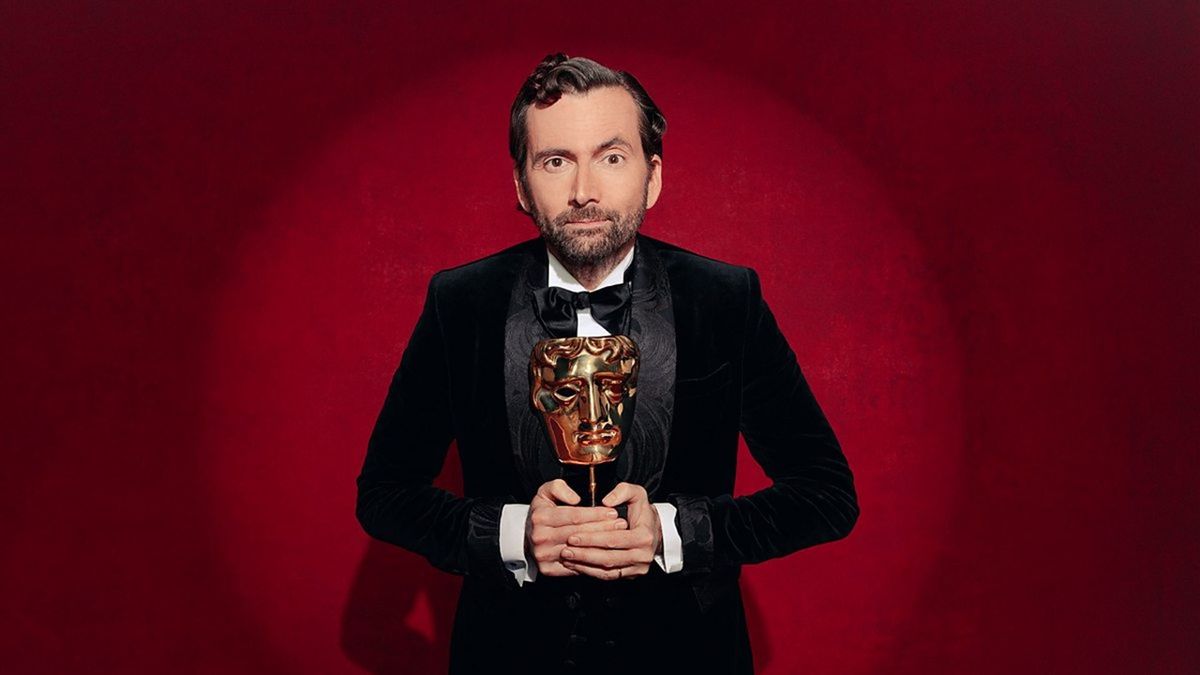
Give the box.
[526,478,662,579]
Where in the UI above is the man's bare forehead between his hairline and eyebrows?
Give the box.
[526,86,642,153]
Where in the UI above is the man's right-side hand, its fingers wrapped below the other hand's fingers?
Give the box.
[562,483,662,579]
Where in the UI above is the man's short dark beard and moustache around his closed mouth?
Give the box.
[529,181,649,269]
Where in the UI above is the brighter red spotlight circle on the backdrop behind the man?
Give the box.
[200,52,962,674]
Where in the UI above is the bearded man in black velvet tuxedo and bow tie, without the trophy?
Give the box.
[356,54,858,674]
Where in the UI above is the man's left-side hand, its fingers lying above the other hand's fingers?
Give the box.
[526,478,628,577]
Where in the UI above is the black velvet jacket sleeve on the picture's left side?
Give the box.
[355,270,516,587]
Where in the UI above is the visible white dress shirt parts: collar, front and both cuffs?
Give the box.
[500,243,683,585]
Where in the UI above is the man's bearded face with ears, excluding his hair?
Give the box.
[514,86,662,265]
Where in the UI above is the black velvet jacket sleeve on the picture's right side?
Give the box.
[672,265,858,573]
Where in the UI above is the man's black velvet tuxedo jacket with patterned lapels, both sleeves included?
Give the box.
[356,235,858,675]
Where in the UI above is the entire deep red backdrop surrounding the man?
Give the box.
[0,1,1200,673]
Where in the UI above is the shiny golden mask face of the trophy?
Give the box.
[529,335,637,465]
